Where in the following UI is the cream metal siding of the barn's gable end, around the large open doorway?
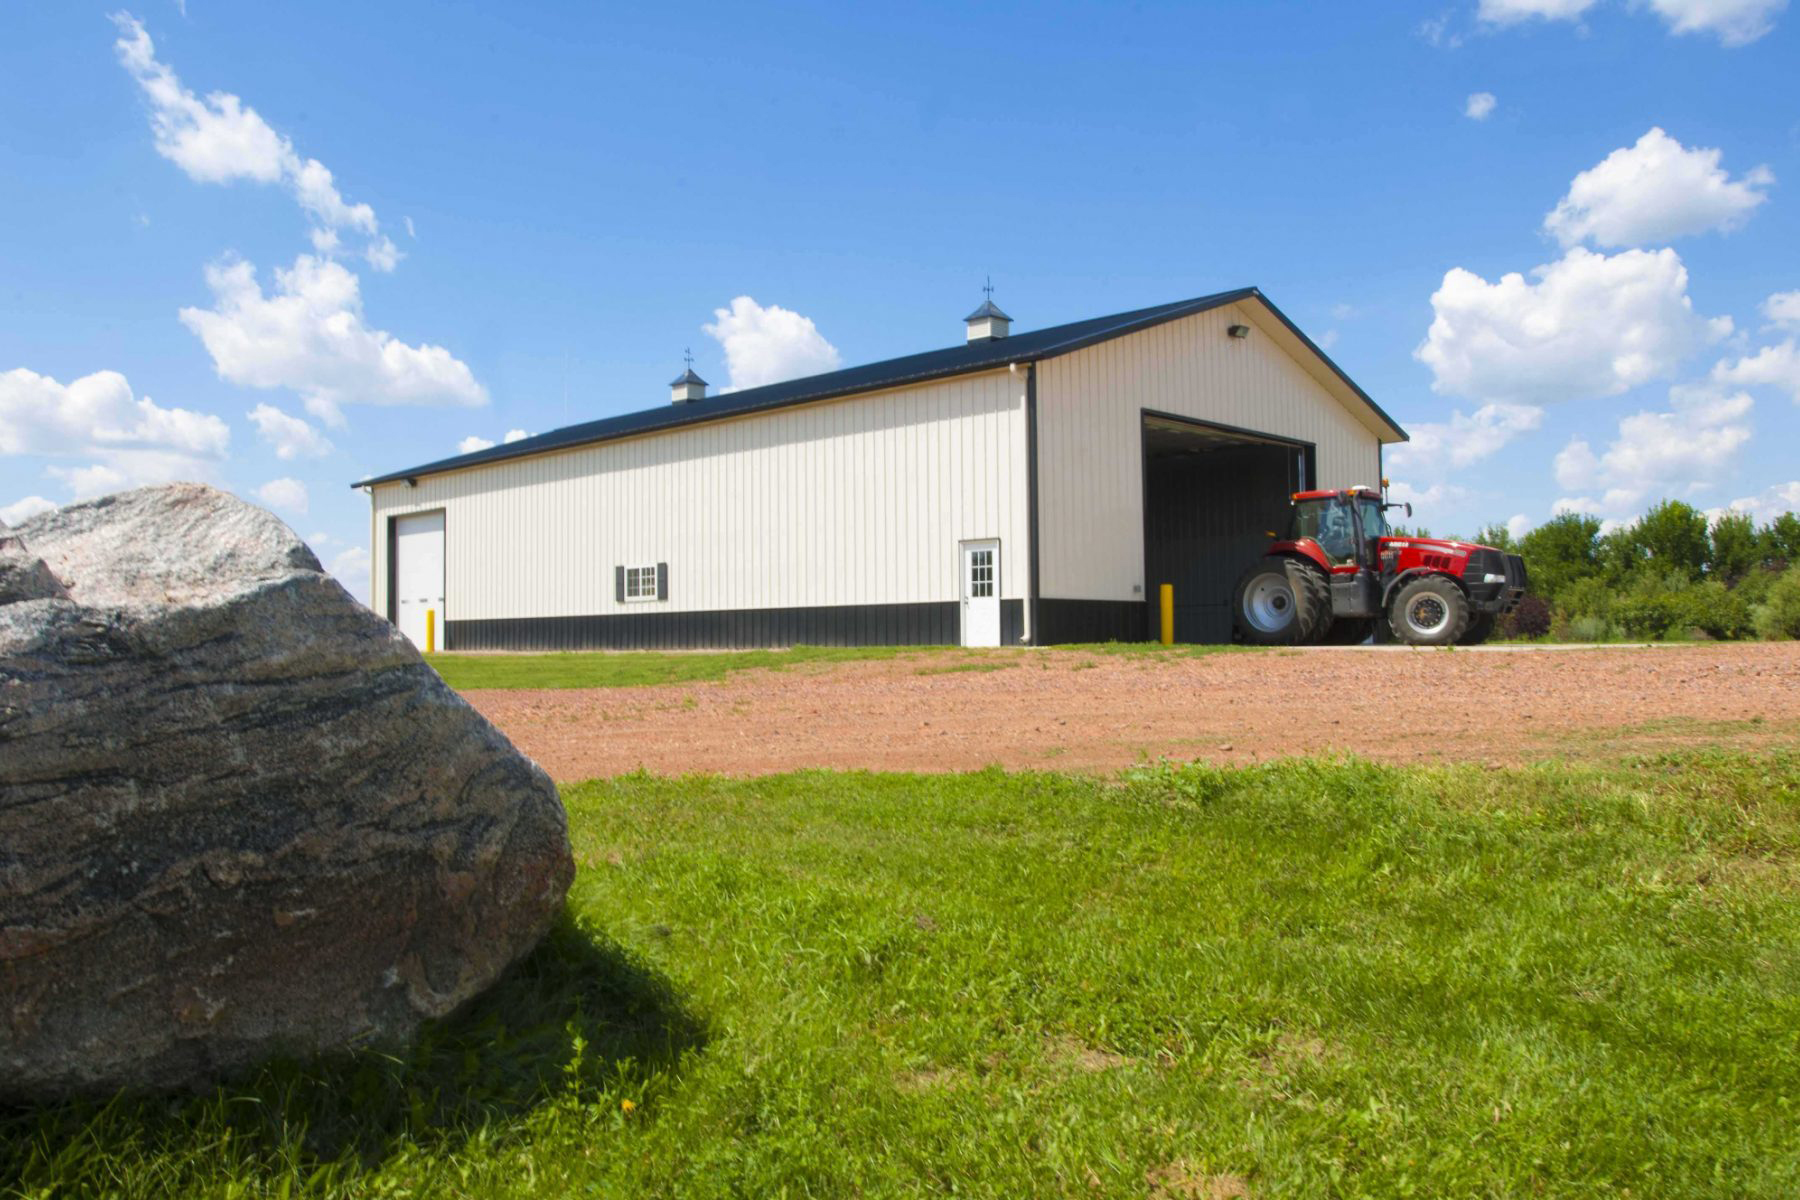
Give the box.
[1037,304,1381,601]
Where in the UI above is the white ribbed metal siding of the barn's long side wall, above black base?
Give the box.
[373,369,1028,621]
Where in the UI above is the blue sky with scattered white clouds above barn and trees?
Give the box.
[0,0,1800,592]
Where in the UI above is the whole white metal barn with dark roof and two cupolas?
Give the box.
[356,288,1406,649]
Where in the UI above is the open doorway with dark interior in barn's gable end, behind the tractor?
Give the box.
[1143,410,1314,642]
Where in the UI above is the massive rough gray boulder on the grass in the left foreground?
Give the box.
[0,484,574,1099]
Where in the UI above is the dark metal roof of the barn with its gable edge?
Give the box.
[351,288,1406,488]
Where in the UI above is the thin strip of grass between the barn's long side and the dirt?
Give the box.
[427,642,1260,691]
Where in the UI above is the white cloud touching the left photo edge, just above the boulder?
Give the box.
[0,369,230,500]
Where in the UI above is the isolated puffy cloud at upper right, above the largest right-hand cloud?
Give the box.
[1544,128,1775,246]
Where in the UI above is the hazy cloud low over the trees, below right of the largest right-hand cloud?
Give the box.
[1555,387,1755,516]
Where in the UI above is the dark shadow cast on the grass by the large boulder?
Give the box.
[0,914,706,1195]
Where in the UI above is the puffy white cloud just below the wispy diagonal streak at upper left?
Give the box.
[182,254,488,425]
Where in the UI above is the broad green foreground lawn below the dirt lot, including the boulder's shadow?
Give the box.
[0,754,1800,1198]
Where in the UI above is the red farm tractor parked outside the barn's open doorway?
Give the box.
[1231,488,1525,646]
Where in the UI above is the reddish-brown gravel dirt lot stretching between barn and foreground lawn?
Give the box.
[466,642,1800,781]
